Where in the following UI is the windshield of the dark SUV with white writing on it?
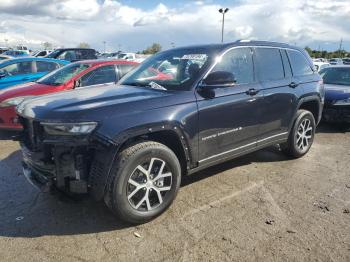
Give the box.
[119,48,213,91]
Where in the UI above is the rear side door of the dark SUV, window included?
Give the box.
[254,47,298,146]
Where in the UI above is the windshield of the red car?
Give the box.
[36,64,90,86]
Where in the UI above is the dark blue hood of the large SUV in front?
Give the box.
[17,85,172,122]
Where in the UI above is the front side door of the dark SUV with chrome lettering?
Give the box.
[197,47,262,165]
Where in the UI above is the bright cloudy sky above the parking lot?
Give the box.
[0,0,350,51]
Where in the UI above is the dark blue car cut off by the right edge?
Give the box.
[320,65,350,123]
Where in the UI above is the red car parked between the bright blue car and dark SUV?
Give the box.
[0,60,138,130]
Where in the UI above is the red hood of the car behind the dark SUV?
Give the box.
[0,82,54,102]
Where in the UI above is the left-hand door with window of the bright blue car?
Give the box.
[0,61,34,89]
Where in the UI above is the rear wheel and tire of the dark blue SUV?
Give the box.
[281,110,316,158]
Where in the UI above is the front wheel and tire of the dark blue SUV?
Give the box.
[105,141,181,224]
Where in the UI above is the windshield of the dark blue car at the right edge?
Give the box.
[320,67,350,86]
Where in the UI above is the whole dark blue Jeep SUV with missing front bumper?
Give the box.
[17,41,324,223]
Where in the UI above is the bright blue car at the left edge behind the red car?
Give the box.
[0,57,69,90]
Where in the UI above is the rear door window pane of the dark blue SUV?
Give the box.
[255,47,284,81]
